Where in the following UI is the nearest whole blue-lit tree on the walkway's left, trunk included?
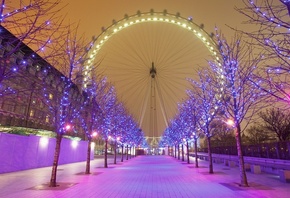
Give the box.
[43,26,89,187]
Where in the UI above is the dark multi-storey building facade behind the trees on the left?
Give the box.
[0,26,85,136]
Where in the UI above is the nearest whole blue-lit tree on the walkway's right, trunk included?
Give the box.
[210,33,266,186]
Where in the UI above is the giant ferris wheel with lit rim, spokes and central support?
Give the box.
[83,10,219,147]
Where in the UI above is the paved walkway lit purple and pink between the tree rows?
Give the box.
[0,156,290,198]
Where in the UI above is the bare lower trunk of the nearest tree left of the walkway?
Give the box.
[49,133,62,187]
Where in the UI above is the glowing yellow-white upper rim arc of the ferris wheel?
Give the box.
[82,10,220,89]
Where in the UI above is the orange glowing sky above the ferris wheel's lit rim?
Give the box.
[63,0,247,41]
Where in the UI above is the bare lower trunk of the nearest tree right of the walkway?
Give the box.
[236,124,249,187]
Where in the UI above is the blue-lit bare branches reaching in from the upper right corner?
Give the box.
[236,0,290,104]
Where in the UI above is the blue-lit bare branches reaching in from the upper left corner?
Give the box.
[0,0,64,128]
